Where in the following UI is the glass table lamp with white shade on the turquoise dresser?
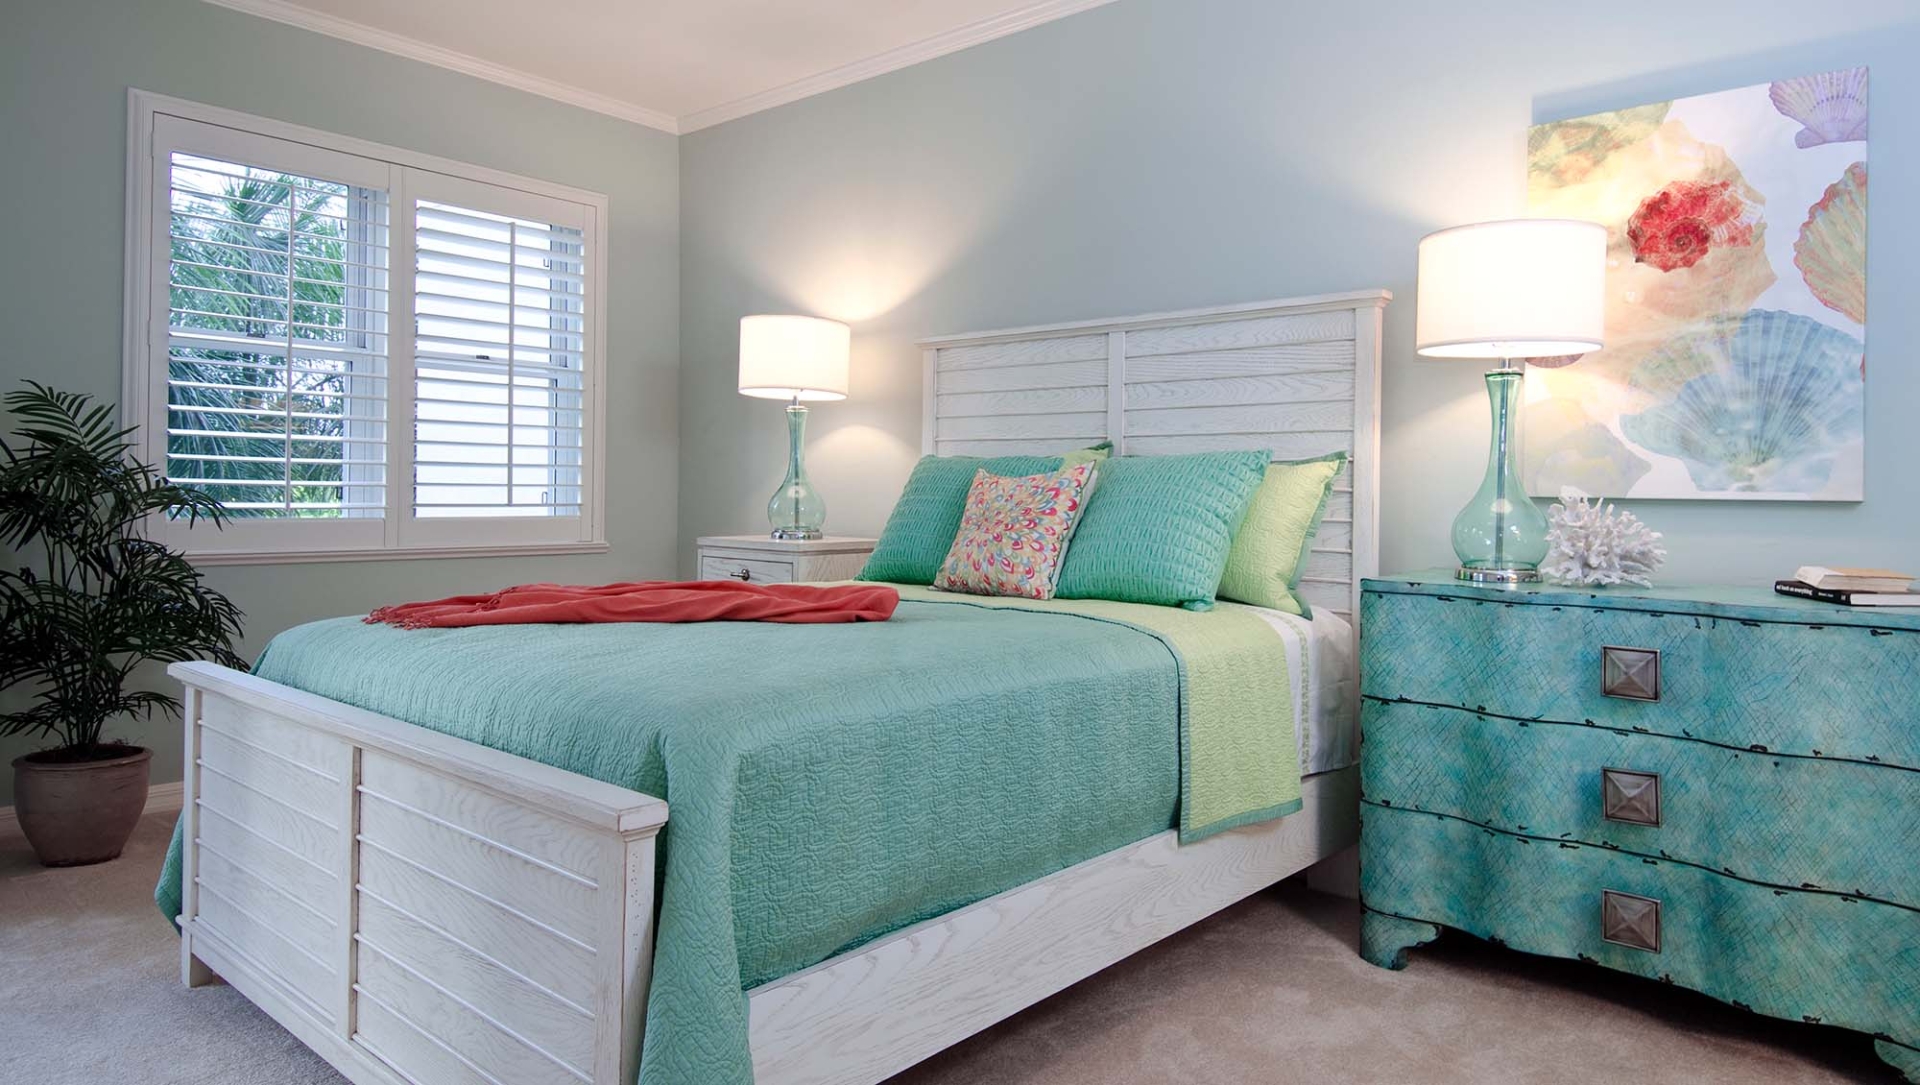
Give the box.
[1413,219,1607,584]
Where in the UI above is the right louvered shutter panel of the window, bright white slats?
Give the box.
[413,200,588,518]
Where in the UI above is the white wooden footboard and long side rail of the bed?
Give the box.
[171,663,1357,1085]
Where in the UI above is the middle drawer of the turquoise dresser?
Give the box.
[1361,701,1920,902]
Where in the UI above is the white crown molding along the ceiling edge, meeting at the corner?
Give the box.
[194,0,1114,134]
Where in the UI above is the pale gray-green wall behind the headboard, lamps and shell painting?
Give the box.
[680,0,1920,582]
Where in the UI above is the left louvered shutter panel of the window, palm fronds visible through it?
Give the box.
[167,152,388,518]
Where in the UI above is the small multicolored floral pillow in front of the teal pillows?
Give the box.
[933,463,1100,599]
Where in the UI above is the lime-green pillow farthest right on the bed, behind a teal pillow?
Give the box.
[1219,451,1346,618]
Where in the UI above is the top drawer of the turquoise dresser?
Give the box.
[1361,591,1920,768]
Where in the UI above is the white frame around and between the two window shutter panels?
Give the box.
[121,90,609,565]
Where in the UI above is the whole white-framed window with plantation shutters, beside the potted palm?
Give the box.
[127,92,605,561]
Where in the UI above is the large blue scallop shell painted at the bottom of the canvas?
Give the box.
[1620,309,1864,494]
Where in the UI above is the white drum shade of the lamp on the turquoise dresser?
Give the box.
[1413,219,1607,359]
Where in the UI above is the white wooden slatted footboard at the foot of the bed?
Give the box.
[171,663,666,1085]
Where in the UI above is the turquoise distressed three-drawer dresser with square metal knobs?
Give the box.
[1359,570,1920,1081]
